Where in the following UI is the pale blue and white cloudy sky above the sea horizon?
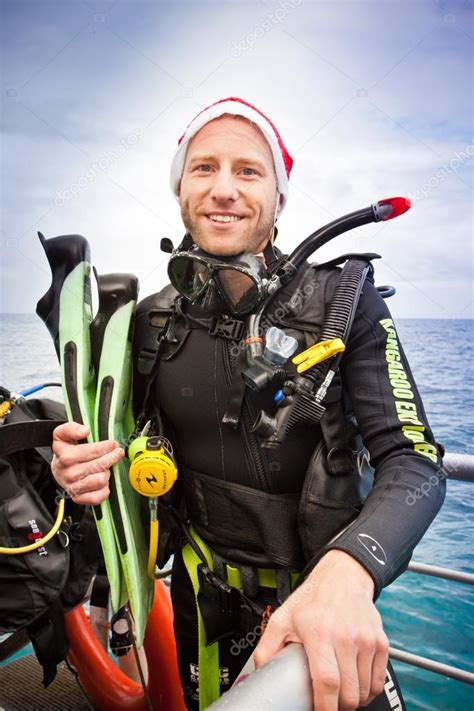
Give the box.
[0,0,474,318]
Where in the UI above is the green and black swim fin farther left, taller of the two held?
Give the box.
[36,233,126,610]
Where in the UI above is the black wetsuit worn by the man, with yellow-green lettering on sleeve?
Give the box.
[136,262,445,709]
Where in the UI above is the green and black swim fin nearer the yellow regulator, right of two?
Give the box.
[92,273,154,646]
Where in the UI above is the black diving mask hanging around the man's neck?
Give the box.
[168,247,268,316]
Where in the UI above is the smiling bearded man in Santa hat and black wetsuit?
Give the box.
[52,97,444,711]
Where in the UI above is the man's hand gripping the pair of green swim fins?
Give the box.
[51,422,125,506]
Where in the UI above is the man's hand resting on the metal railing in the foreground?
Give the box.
[254,550,388,711]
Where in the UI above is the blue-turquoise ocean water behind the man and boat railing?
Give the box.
[0,314,474,711]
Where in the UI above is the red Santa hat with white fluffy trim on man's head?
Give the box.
[170,96,293,212]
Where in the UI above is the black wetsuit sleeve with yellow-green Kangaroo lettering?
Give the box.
[320,281,446,596]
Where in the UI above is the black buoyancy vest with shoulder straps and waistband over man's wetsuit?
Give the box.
[134,254,378,570]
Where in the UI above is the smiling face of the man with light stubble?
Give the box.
[179,115,279,257]
